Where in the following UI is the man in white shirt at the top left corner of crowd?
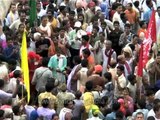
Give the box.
[7,3,19,25]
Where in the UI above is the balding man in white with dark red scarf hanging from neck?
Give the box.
[102,40,117,75]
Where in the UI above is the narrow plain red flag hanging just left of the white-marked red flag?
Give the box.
[137,43,143,77]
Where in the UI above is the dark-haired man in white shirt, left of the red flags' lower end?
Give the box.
[114,65,127,98]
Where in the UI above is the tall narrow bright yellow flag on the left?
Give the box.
[21,32,30,102]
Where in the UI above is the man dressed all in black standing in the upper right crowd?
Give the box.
[108,21,123,55]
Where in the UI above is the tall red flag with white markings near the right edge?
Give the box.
[143,10,156,68]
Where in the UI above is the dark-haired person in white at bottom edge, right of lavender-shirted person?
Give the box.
[59,100,74,120]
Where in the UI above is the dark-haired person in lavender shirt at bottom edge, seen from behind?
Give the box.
[37,98,56,120]
